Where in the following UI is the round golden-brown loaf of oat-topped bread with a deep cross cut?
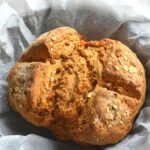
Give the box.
[8,27,146,145]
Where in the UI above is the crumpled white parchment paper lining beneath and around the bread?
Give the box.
[0,0,150,150]
